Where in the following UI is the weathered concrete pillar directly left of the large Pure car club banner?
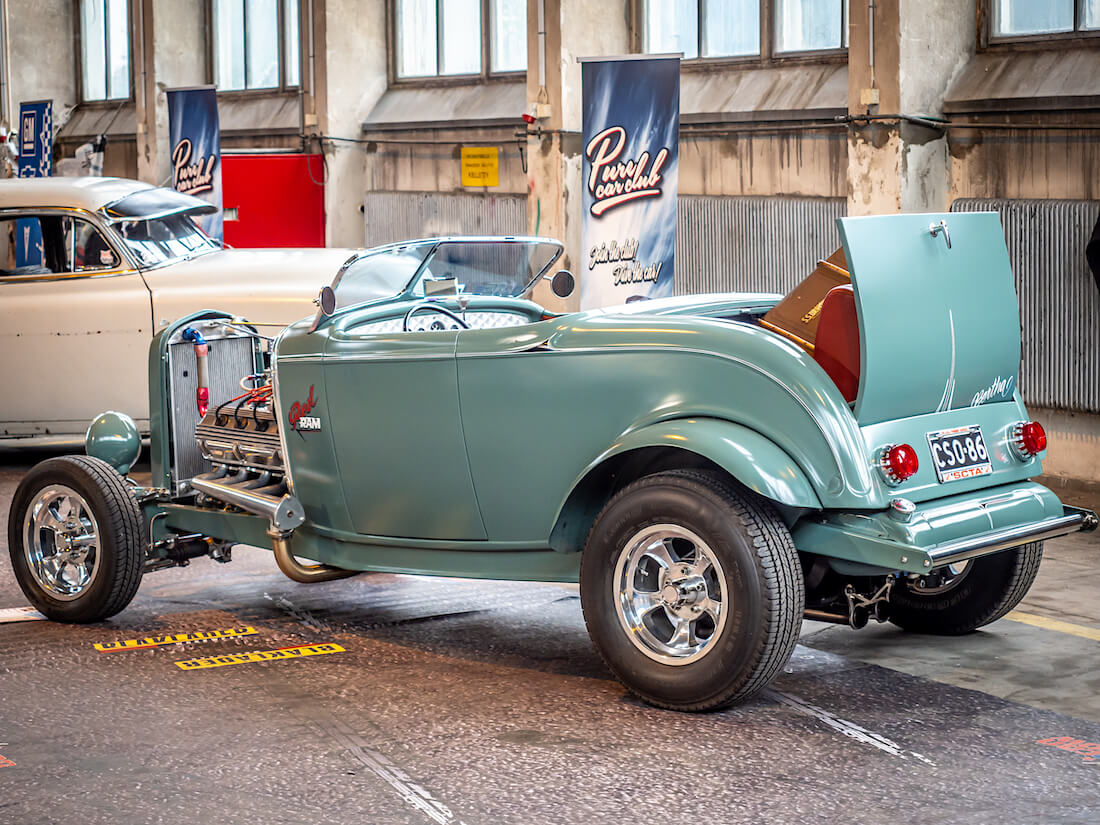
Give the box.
[527,0,630,309]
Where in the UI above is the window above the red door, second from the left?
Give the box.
[212,0,300,91]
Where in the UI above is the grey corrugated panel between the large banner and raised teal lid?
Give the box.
[675,195,846,295]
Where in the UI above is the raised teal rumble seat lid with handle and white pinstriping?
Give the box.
[837,212,1020,425]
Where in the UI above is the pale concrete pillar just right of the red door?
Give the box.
[319,0,388,246]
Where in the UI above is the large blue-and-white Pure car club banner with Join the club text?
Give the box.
[580,55,680,309]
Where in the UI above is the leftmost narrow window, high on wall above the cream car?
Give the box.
[80,0,130,100]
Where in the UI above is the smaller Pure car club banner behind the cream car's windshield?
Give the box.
[168,86,222,242]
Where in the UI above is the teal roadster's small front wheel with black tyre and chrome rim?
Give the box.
[8,455,144,623]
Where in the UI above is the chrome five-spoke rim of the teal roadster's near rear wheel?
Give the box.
[612,524,727,664]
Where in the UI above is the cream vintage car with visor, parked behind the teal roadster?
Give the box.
[0,177,352,441]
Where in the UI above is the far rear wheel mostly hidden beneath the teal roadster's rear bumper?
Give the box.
[890,541,1043,636]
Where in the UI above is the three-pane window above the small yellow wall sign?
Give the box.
[393,0,527,79]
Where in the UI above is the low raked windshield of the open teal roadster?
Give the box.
[333,239,561,309]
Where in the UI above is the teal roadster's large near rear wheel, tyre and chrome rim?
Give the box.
[581,471,804,711]
